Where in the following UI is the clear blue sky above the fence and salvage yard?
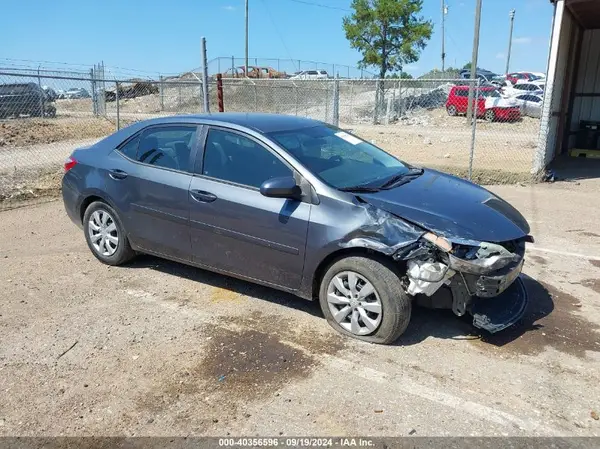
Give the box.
[0,0,553,75]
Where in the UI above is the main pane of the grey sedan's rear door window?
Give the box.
[136,126,197,172]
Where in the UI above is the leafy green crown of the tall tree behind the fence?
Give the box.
[344,0,433,79]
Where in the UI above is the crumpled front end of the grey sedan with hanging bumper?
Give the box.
[393,232,532,333]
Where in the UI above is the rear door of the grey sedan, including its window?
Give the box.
[106,124,199,261]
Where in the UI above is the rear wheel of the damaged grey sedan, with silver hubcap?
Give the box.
[83,201,135,265]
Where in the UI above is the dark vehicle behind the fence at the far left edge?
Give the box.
[0,83,56,118]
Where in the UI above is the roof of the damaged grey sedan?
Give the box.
[134,112,324,134]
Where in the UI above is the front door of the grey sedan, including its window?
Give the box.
[190,127,311,289]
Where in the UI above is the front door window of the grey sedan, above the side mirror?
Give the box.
[202,129,292,188]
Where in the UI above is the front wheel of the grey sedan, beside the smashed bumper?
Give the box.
[319,256,412,344]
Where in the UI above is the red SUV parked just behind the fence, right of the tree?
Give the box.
[446,86,521,122]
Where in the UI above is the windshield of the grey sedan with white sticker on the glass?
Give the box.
[267,125,409,189]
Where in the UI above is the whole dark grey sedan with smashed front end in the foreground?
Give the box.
[62,113,533,344]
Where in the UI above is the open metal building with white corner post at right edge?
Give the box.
[533,0,600,176]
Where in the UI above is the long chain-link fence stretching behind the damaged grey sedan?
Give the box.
[0,70,541,207]
